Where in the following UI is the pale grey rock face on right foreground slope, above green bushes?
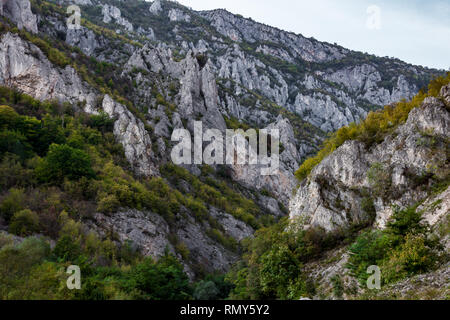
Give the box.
[290,86,450,231]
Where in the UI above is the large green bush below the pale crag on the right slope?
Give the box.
[347,207,439,285]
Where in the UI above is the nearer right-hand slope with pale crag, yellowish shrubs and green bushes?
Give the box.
[229,79,450,300]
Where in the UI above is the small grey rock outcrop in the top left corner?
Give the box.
[0,0,38,33]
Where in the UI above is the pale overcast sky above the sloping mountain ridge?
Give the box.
[171,0,450,70]
